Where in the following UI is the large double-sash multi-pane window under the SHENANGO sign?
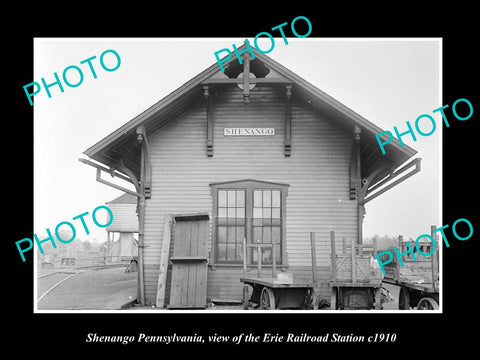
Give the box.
[211,180,288,265]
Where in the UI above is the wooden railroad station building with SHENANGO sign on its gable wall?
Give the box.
[82,45,420,306]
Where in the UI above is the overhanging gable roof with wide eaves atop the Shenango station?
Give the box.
[84,44,416,183]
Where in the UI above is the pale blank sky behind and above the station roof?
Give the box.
[31,38,444,242]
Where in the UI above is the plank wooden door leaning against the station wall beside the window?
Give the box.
[168,214,209,308]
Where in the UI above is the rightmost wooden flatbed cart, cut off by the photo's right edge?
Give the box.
[383,226,440,310]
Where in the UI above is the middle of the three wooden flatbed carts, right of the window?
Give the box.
[330,231,382,310]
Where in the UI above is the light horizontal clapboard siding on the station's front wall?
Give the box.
[144,85,358,302]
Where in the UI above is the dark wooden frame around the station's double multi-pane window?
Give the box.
[210,179,290,268]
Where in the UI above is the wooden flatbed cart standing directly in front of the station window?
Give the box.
[240,233,317,310]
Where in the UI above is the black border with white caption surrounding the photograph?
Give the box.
[6,3,480,356]
